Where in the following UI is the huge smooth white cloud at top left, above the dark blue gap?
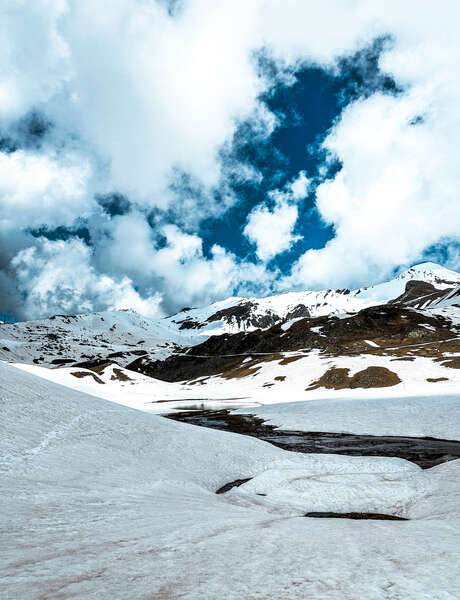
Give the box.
[0,0,374,207]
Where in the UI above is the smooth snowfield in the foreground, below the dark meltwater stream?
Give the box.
[0,364,460,600]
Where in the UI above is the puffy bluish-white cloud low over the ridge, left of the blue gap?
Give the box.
[89,212,273,313]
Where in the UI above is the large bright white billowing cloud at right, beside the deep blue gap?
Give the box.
[285,39,460,287]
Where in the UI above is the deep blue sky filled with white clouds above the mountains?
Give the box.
[0,0,460,320]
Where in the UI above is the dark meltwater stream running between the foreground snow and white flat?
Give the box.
[166,410,460,469]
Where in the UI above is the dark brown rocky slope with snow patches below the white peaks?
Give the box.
[127,304,460,381]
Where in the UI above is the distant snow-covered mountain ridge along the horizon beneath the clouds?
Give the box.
[0,263,460,366]
